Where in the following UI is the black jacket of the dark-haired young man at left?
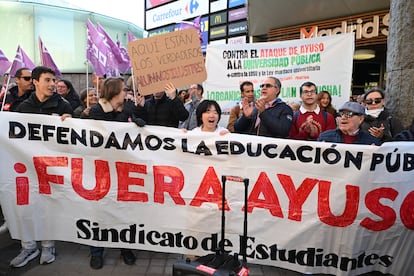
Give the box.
[16,93,73,116]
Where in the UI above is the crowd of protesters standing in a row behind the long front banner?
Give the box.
[0,66,414,269]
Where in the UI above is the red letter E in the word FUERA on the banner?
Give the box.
[116,162,148,202]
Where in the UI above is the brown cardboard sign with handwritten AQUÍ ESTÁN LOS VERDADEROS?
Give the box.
[128,29,207,95]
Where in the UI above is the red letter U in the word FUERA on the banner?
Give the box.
[71,158,111,200]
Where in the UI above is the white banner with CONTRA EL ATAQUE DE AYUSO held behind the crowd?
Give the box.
[204,34,354,111]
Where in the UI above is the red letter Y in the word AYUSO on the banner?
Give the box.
[277,174,319,221]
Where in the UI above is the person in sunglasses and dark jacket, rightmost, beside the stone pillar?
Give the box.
[361,87,403,143]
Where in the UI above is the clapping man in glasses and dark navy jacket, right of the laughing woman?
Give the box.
[234,77,293,138]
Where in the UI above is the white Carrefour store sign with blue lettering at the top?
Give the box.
[145,0,209,30]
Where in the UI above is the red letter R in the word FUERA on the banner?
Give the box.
[153,166,185,205]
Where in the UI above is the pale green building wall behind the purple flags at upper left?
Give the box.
[0,1,145,74]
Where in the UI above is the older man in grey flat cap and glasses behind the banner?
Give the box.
[318,102,381,146]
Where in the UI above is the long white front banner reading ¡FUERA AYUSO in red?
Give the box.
[0,112,414,275]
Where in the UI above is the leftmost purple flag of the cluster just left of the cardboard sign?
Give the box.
[86,20,107,76]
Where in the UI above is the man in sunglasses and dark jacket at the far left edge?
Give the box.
[2,67,34,111]
